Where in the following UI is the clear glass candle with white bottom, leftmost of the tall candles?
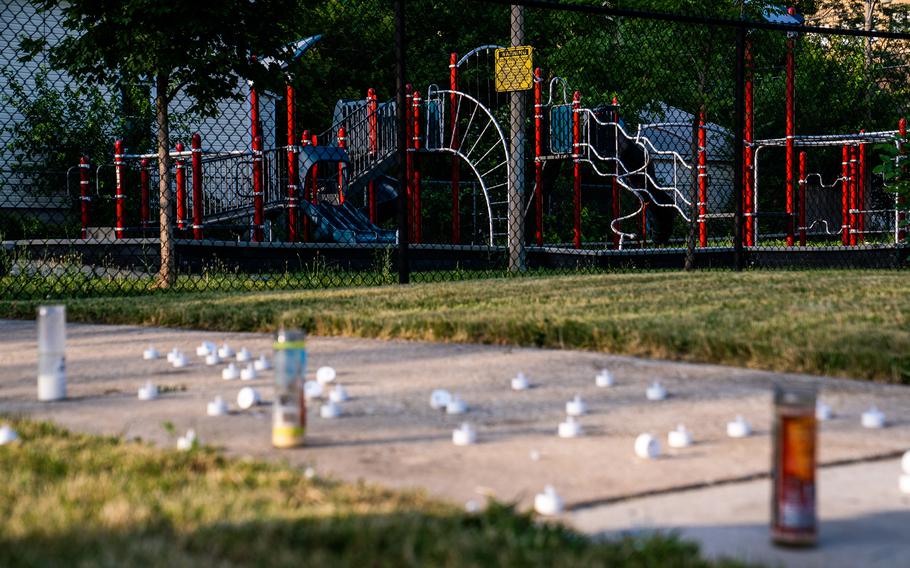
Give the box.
[38,306,66,401]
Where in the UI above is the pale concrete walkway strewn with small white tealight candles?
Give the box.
[0,320,910,566]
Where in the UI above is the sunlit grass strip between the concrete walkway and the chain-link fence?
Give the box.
[0,270,910,383]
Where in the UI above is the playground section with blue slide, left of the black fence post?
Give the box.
[78,82,395,243]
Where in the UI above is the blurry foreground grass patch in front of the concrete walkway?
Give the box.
[0,420,748,567]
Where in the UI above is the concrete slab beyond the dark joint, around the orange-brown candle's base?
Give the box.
[569,458,910,568]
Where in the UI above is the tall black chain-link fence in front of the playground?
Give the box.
[0,0,910,299]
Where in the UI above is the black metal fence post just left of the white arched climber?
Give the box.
[395,0,411,284]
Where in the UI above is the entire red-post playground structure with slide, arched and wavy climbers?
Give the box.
[64,12,905,268]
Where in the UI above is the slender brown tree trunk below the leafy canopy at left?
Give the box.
[155,73,177,288]
